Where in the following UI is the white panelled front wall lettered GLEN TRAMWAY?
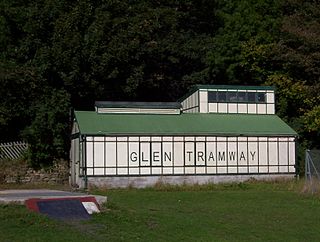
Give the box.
[83,136,295,176]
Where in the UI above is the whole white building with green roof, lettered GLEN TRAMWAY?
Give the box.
[70,85,297,187]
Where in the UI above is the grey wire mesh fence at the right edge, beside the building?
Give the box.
[305,150,320,193]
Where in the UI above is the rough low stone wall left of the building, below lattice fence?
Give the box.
[0,160,69,184]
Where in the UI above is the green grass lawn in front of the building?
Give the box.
[0,181,320,241]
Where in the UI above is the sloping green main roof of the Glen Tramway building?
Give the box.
[75,111,297,136]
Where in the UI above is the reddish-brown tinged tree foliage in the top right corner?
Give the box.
[275,0,320,85]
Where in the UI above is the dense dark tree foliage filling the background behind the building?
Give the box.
[0,0,320,166]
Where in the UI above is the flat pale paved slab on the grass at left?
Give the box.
[0,189,107,205]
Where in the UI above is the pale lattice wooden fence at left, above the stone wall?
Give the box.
[0,141,28,159]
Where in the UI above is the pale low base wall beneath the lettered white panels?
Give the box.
[84,174,295,188]
